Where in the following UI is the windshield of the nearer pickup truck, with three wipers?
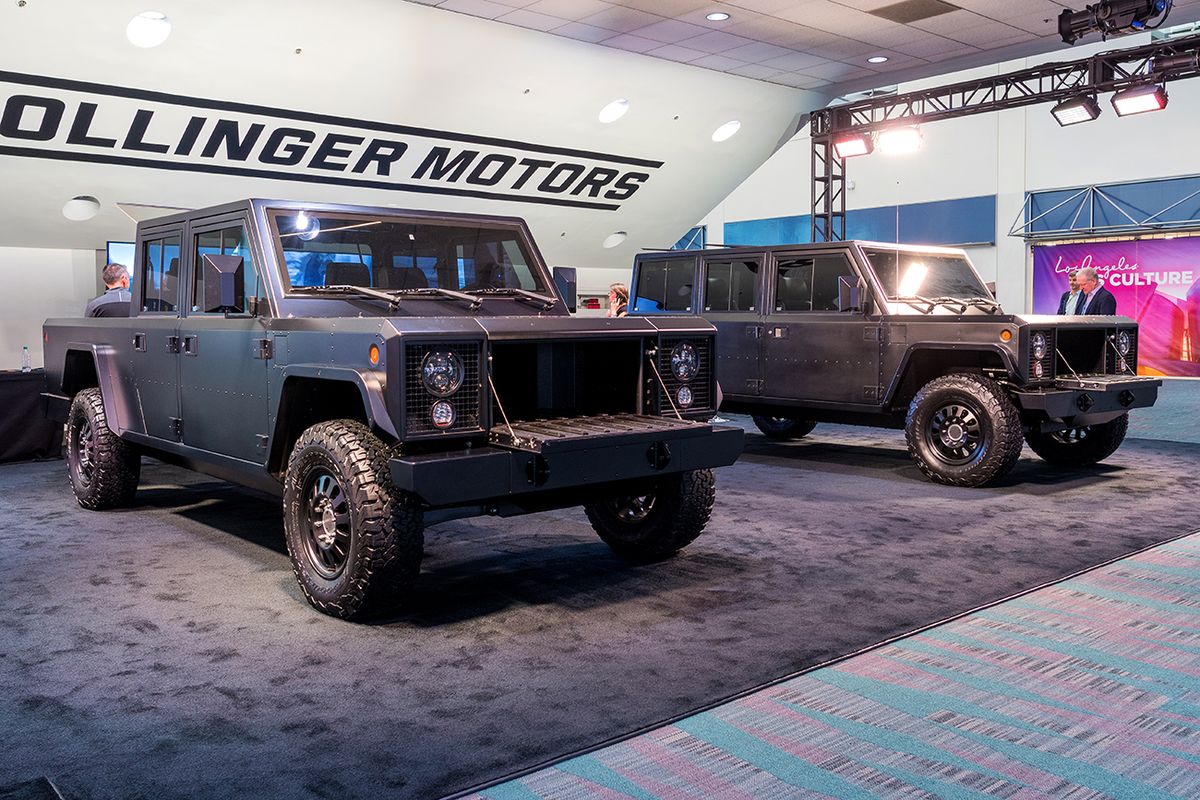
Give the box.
[270,211,546,291]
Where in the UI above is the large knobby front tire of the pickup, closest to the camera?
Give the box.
[283,420,425,619]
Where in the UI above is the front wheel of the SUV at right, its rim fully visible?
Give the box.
[905,373,1022,486]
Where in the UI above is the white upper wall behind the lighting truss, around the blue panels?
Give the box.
[703,36,1200,312]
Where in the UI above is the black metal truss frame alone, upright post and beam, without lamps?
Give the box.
[810,35,1200,241]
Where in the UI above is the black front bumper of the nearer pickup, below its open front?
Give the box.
[390,415,744,507]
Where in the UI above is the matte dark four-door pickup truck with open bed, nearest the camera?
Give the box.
[44,200,743,618]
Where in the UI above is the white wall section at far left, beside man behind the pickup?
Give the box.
[0,247,98,369]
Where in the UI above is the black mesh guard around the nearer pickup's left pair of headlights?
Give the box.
[400,341,486,440]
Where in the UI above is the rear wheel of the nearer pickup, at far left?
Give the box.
[66,389,142,511]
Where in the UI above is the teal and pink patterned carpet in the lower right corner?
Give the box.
[469,531,1200,800]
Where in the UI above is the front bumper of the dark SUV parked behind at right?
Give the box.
[1016,375,1163,425]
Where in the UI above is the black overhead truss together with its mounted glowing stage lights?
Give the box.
[810,31,1200,241]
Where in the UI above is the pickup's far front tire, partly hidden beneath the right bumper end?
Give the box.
[583,469,716,564]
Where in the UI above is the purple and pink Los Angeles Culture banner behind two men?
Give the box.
[1033,237,1200,378]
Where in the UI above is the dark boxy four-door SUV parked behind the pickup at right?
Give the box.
[630,241,1162,486]
